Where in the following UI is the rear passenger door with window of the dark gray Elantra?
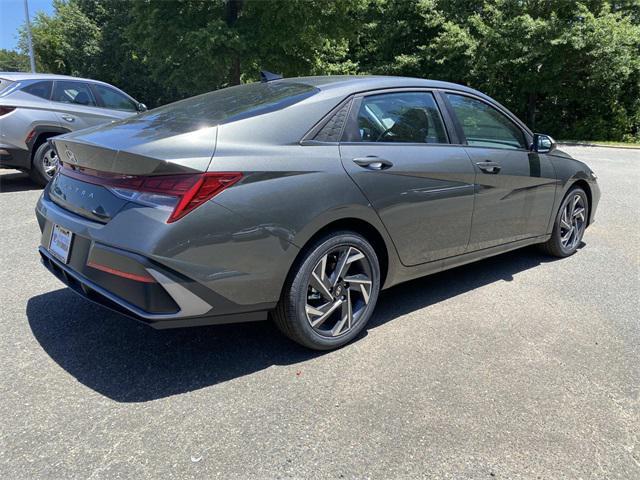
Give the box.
[340,90,475,265]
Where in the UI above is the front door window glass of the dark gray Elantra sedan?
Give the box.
[447,94,527,149]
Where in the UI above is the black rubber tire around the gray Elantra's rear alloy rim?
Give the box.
[272,231,380,350]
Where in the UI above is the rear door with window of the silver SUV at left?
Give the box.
[51,80,118,130]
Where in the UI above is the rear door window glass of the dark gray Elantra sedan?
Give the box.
[357,92,448,143]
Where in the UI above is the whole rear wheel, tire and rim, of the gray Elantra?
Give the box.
[273,232,380,350]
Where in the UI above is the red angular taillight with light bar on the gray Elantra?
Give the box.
[60,163,242,223]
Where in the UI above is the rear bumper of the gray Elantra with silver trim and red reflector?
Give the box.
[36,190,275,329]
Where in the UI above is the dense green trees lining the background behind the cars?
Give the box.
[12,0,640,140]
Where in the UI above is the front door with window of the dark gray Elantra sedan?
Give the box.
[445,92,556,251]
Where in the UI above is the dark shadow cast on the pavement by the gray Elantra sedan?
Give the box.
[27,248,564,402]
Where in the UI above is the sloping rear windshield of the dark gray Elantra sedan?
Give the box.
[131,82,319,131]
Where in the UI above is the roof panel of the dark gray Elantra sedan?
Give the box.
[276,75,486,97]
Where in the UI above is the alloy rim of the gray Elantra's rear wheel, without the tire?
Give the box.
[305,245,372,337]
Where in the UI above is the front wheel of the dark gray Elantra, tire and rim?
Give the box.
[543,187,589,258]
